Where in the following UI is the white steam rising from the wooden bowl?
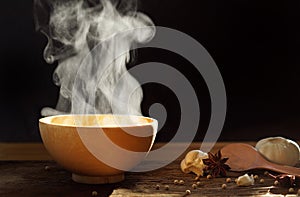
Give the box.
[35,0,155,116]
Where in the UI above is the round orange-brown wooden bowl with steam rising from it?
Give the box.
[39,114,157,184]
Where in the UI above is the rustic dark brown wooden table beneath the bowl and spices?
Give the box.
[0,142,298,197]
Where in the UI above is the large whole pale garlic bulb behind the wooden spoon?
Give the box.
[255,137,300,166]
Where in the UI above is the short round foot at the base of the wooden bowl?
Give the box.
[72,173,125,184]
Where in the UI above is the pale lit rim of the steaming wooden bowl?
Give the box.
[39,114,157,128]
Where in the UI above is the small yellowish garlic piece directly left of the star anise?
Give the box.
[180,150,208,176]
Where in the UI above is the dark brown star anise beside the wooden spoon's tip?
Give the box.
[202,150,230,177]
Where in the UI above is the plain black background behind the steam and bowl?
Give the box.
[0,0,300,141]
